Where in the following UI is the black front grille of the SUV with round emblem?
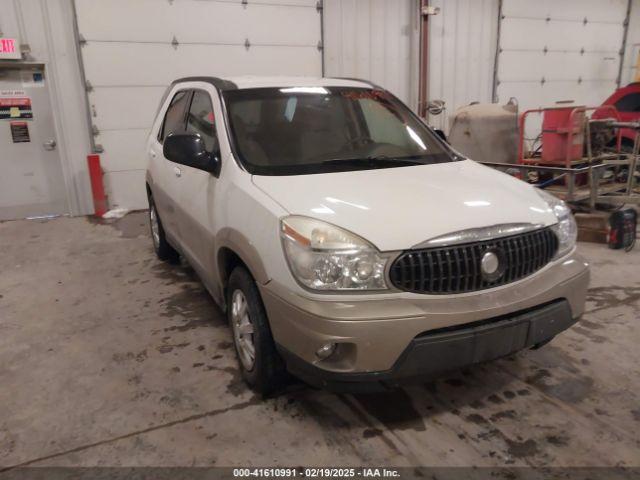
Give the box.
[389,228,558,294]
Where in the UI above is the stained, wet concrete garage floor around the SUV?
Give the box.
[0,213,640,467]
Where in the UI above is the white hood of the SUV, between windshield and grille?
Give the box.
[253,160,556,251]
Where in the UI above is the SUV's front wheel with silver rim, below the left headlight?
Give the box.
[227,267,286,395]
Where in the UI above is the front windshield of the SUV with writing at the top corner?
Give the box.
[224,87,457,175]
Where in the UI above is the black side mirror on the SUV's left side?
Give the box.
[162,133,220,175]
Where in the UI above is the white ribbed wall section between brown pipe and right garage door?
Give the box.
[427,0,498,131]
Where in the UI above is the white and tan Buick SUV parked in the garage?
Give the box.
[147,77,589,392]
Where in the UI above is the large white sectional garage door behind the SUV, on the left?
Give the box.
[75,0,322,208]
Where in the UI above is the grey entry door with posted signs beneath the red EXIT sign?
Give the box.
[0,65,69,220]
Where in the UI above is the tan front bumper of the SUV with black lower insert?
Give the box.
[260,252,589,385]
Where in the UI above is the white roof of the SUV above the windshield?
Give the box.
[173,75,379,90]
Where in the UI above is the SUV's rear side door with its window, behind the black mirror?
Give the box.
[149,89,192,243]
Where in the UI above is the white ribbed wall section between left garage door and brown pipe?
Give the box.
[324,0,419,108]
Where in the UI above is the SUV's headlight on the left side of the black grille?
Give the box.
[280,216,387,290]
